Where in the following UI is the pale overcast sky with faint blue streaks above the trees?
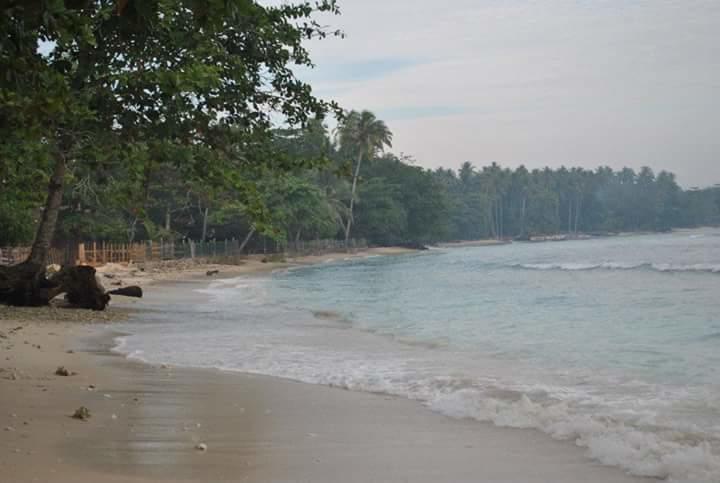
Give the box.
[292,0,720,188]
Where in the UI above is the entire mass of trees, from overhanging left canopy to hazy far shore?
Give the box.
[0,0,720,263]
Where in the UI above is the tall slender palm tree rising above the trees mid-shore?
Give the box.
[337,111,392,248]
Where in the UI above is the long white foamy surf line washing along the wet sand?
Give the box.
[113,336,720,483]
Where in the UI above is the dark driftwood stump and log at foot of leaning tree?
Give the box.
[0,262,142,310]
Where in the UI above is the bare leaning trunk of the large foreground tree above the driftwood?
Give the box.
[28,158,66,264]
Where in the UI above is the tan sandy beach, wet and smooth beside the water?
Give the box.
[0,250,648,483]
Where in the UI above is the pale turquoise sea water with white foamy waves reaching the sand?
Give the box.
[118,229,720,482]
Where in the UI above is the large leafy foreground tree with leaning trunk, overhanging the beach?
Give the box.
[0,0,338,304]
